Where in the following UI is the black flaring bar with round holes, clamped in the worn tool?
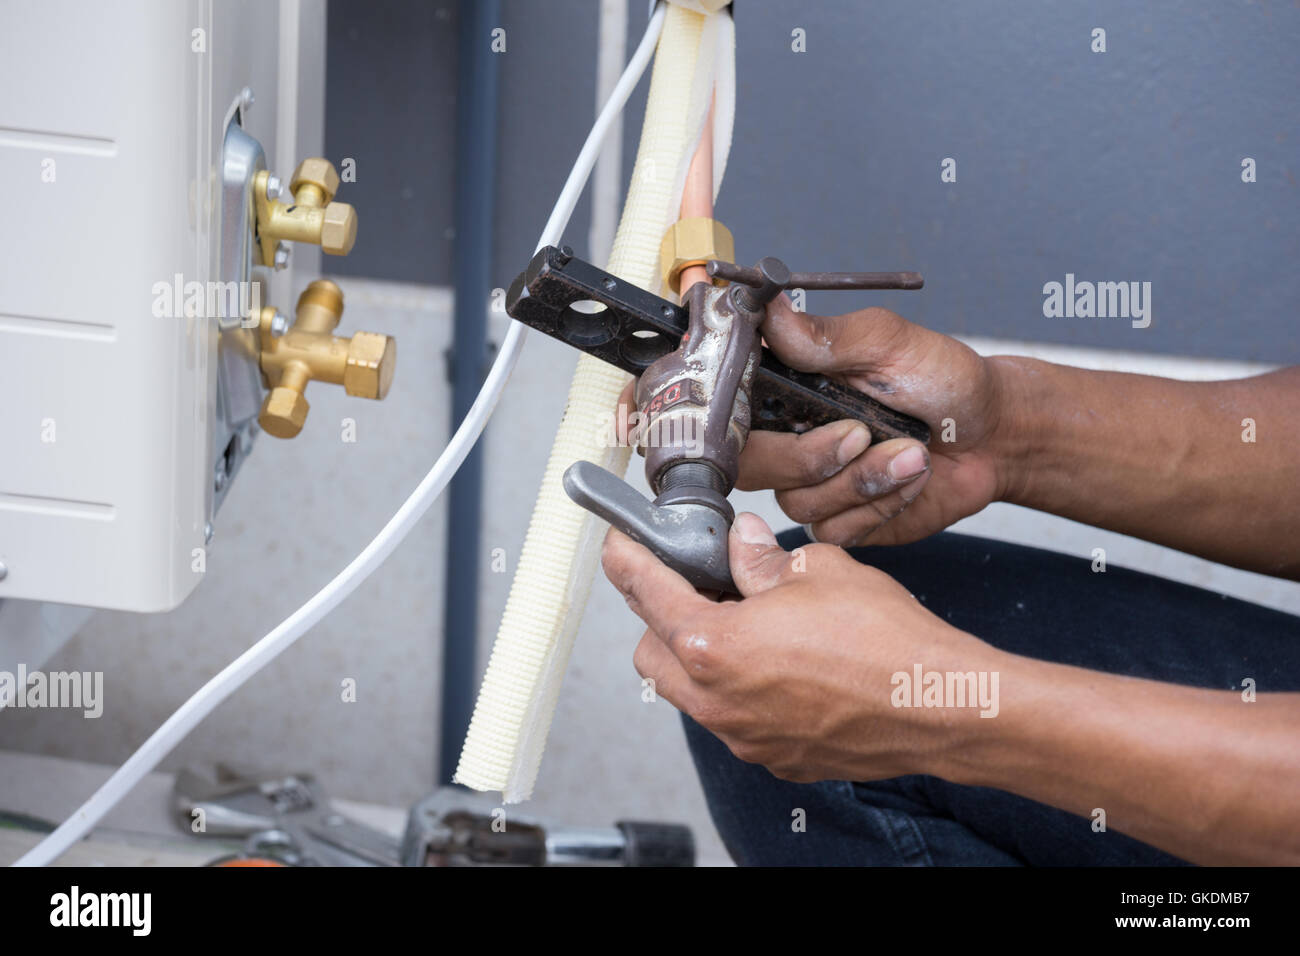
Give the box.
[506,246,930,444]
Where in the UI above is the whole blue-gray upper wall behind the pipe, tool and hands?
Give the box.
[326,0,1300,362]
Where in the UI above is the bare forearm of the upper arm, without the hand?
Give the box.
[989,356,1300,578]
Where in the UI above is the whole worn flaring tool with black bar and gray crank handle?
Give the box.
[506,247,930,593]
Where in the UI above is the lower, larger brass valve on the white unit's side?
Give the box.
[257,278,397,438]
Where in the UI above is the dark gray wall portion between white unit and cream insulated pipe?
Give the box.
[325,0,603,290]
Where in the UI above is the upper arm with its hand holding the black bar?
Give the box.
[737,298,1300,578]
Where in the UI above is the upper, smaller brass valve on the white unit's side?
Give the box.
[254,157,356,265]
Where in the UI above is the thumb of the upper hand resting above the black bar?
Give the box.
[762,297,920,372]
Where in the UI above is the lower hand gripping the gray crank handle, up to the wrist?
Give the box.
[602,514,1006,782]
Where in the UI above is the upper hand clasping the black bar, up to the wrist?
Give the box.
[736,295,1002,545]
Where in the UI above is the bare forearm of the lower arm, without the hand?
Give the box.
[939,654,1300,865]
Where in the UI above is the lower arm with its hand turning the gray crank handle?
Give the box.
[603,515,1300,865]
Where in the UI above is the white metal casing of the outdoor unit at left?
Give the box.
[0,0,305,611]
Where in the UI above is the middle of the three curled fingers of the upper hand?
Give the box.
[776,438,930,528]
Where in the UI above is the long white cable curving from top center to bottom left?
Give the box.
[14,3,667,866]
